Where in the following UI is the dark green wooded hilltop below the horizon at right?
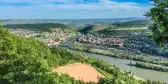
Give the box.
[112,20,152,28]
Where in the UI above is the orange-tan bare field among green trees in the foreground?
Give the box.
[52,63,104,82]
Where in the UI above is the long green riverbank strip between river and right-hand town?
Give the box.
[69,44,168,67]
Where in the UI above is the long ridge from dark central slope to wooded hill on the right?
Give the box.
[79,20,152,34]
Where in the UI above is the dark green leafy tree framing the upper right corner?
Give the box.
[145,0,168,44]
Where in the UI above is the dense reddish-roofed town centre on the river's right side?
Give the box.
[78,35,124,47]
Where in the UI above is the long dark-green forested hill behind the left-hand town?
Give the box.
[3,23,69,31]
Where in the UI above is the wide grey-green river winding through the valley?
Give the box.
[60,35,168,83]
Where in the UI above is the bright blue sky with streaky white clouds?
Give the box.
[0,0,153,19]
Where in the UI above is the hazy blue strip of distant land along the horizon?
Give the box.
[0,17,148,25]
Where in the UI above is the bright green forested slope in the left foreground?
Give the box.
[0,28,88,84]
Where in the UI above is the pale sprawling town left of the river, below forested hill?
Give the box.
[10,28,75,46]
